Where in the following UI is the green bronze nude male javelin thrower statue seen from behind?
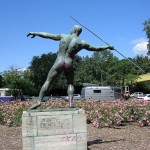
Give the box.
[27,25,114,109]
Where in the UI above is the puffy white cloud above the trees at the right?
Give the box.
[131,38,148,56]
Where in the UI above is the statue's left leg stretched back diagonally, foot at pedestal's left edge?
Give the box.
[30,64,59,109]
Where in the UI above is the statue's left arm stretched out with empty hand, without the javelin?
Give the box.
[27,32,61,40]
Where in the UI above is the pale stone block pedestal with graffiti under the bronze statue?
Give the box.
[22,108,87,150]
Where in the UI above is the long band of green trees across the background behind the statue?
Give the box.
[2,51,150,95]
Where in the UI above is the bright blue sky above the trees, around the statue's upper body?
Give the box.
[0,0,150,73]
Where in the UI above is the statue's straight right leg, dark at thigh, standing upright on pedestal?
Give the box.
[65,68,74,107]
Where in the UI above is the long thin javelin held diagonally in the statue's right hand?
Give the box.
[69,16,145,73]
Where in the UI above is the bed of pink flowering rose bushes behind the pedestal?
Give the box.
[0,100,150,128]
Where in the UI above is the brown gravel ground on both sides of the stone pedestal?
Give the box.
[0,124,150,150]
